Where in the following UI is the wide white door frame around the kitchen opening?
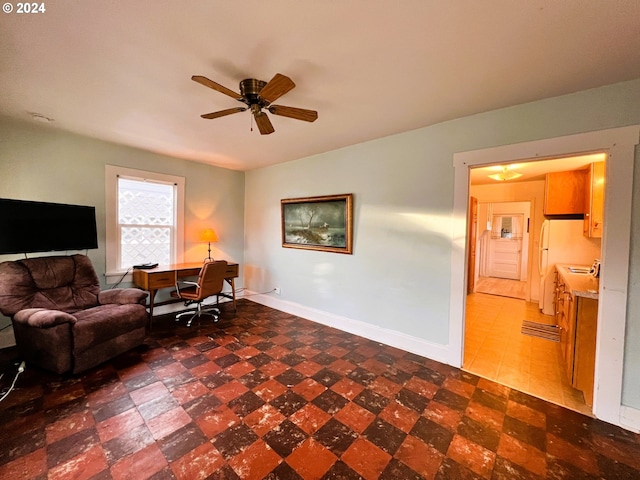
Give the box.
[448,125,640,426]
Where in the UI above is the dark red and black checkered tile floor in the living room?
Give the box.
[0,300,640,480]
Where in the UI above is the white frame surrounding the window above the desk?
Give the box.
[105,165,185,284]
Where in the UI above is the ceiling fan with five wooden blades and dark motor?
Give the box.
[191,73,318,135]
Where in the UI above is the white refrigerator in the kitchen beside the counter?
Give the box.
[538,219,600,315]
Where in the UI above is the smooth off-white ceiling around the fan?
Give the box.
[0,0,640,170]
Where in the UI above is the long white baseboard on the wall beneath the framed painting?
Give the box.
[246,291,450,363]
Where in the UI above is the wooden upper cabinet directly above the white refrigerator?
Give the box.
[544,169,586,215]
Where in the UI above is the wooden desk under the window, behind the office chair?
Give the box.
[133,262,238,319]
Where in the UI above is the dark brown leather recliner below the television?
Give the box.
[0,255,147,373]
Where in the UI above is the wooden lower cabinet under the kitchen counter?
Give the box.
[555,275,598,406]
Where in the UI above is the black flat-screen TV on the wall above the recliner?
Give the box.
[0,198,98,254]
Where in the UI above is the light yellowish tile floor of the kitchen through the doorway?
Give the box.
[463,293,592,415]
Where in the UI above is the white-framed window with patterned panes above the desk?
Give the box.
[106,165,184,283]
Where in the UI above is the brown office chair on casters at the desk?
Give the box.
[171,260,227,327]
